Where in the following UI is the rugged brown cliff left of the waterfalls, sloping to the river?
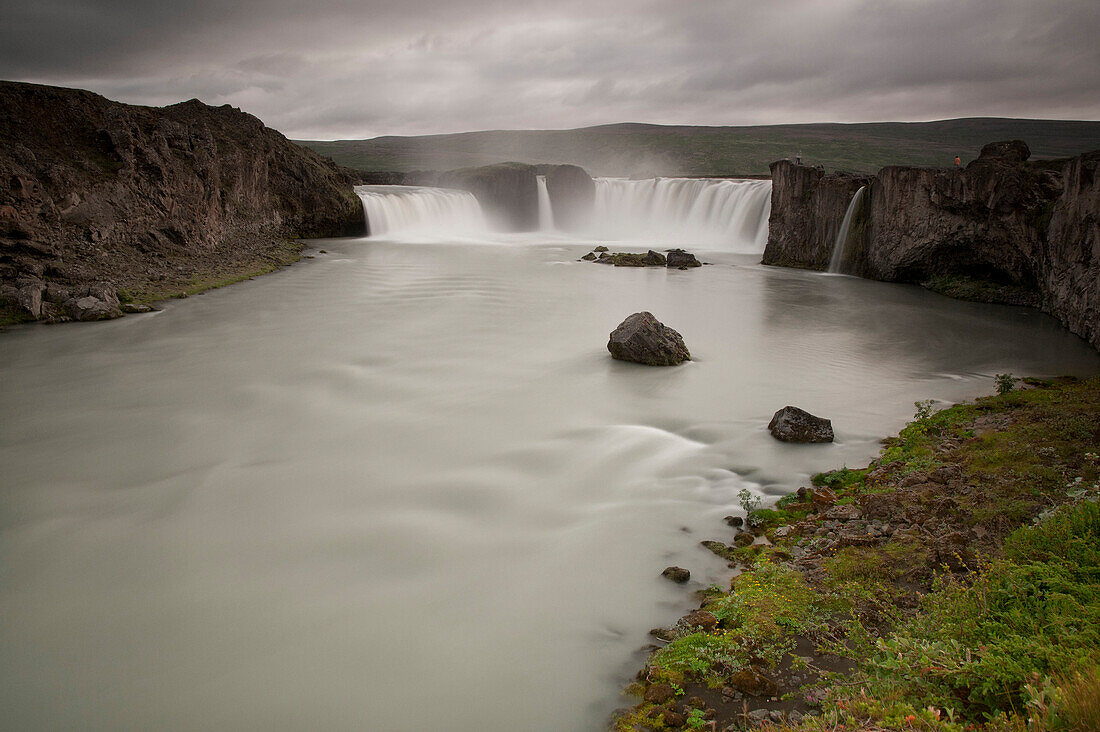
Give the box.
[0,81,363,320]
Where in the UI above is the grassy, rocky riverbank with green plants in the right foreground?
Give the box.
[614,378,1100,732]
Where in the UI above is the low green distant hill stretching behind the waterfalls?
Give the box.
[298,118,1100,175]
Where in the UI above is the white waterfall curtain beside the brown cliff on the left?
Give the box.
[355,186,486,239]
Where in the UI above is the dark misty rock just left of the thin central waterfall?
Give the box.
[437,163,539,231]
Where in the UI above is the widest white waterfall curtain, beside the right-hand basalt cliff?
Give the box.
[592,178,771,253]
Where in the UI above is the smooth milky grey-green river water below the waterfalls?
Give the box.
[0,237,1100,731]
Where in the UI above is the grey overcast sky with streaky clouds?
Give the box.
[0,0,1100,139]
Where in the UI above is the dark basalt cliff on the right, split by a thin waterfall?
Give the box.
[763,141,1100,349]
